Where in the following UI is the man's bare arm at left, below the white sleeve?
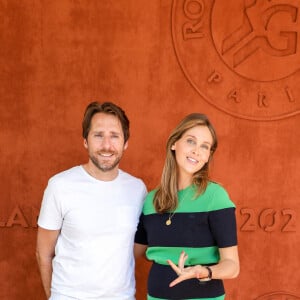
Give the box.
[36,227,60,299]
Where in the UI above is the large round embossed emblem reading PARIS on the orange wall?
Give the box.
[172,0,300,120]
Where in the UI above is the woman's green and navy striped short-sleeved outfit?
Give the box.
[135,182,237,300]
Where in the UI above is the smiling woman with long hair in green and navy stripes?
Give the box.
[135,113,239,300]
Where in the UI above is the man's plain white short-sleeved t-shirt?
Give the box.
[38,166,147,300]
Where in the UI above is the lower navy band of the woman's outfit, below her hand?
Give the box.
[148,263,225,300]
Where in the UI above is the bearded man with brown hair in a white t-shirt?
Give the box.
[36,102,146,300]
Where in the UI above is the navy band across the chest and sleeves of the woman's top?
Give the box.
[135,207,237,248]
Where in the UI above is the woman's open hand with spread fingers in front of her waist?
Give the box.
[167,251,208,287]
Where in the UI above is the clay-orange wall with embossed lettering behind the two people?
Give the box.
[0,0,300,300]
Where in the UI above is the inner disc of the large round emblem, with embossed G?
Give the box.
[212,0,300,81]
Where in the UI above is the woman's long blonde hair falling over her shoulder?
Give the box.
[153,113,218,213]
